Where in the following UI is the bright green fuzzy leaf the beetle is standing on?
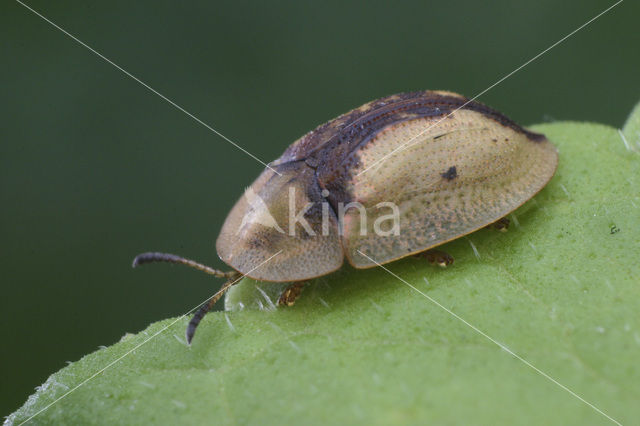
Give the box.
[8,104,640,424]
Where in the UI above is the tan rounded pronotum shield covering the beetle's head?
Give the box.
[216,162,344,281]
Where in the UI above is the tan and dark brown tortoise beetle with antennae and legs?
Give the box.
[133,91,558,343]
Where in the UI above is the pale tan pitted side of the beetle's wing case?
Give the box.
[343,110,557,267]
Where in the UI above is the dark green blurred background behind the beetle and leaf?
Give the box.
[0,0,640,415]
